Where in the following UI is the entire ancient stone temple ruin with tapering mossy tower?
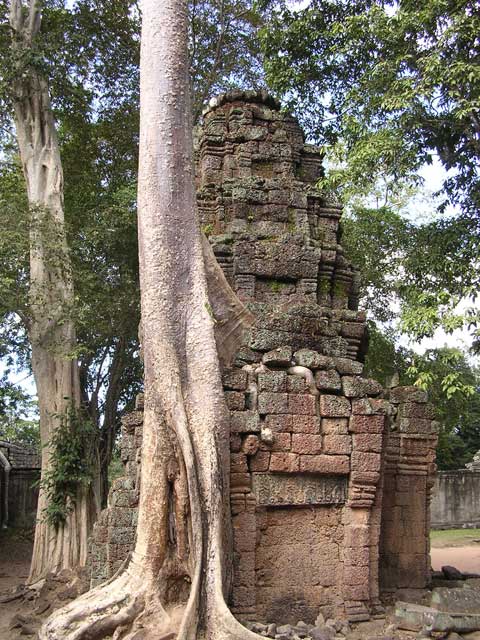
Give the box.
[91,92,436,622]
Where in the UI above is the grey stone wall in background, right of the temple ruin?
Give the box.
[431,469,480,529]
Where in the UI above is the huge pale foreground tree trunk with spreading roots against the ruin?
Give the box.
[40,0,257,640]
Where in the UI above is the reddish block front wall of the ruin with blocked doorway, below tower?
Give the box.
[224,347,386,622]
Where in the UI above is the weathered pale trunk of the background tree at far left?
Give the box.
[10,0,96,582]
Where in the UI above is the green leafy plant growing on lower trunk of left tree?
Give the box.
[40,405,97,528]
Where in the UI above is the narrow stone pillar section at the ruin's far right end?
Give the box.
[380,387,438,593]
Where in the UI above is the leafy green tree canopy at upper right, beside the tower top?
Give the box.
[262,0,480,348]
